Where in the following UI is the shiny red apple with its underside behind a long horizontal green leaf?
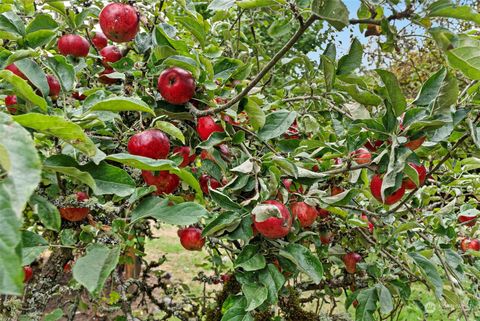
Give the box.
[127,129,170,159]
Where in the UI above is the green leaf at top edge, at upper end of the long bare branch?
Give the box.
[312,0,350,30]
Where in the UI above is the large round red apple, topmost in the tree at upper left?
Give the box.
[98,3,140,42]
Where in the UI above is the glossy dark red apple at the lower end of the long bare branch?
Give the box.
[157,67,195,105]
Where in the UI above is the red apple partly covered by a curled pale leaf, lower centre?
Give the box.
[253,200,292,239]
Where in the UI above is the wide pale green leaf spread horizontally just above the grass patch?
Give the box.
[132,196,208,225]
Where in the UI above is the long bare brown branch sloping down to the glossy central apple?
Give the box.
[187,15,318,117]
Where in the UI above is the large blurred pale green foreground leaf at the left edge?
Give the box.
[0,112,41,295]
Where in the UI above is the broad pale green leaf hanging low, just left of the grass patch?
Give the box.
[73,244,120,295]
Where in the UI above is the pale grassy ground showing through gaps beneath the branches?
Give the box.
[142,226,459,321]
